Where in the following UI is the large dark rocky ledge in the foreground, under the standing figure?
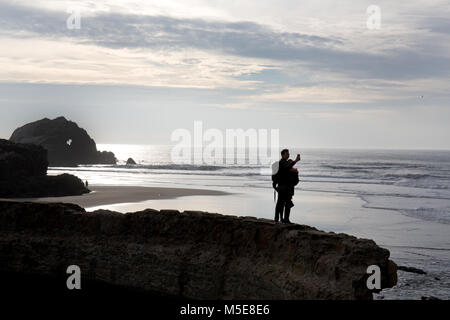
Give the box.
[0,202,397,299]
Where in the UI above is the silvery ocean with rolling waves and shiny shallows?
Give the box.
[49,144,450,299]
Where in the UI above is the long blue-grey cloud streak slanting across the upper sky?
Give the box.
[0,3,450,79]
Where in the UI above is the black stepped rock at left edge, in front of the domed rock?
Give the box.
[0,139,89,198]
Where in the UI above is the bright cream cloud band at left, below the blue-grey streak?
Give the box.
[0,37,274,89]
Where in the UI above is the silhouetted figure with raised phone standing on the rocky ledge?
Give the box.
[272,149,300,223]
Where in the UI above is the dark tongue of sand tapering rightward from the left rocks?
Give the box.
[0,185,230,208]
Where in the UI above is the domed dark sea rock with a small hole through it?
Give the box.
[10,117,116,166]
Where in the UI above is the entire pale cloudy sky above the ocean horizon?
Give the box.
[0,0,450,149]
